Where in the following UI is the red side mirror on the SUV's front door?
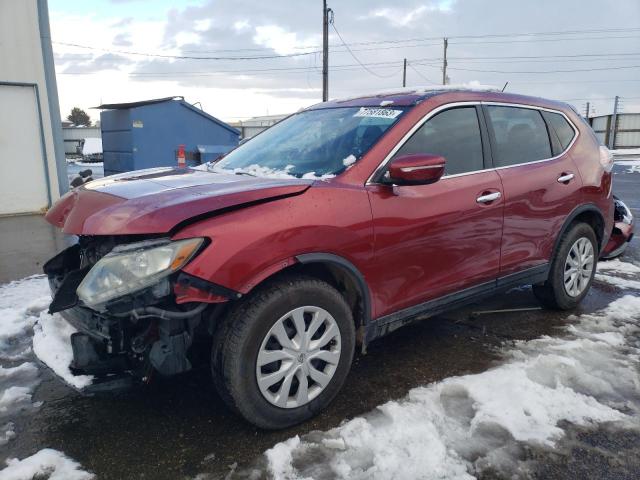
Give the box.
[389,153,447,185]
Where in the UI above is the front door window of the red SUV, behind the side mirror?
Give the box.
[394,107,484,175]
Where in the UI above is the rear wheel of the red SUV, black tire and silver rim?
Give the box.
[533,223,598,310]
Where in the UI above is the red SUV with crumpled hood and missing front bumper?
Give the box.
[45,89,614,428]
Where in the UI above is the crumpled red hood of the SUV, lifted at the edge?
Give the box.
[45,168,313,235]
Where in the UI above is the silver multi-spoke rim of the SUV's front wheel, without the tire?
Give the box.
[256,306,341,408]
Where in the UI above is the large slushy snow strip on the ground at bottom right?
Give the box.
[265,262,640,479]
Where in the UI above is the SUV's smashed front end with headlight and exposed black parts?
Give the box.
[44,236,237,390]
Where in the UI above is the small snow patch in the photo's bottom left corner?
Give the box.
[0,448,95,480]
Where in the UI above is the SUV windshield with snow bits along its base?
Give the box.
[214,107,405,178]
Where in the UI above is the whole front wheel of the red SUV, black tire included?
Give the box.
[211,275,355,430]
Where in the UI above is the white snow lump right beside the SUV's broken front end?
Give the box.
[33,312,93,388]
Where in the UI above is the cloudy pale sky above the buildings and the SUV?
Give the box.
[49,0,640,120]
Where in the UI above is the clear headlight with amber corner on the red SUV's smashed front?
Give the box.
[76,238,204,310]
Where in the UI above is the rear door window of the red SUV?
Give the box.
[487,105,553,167]
